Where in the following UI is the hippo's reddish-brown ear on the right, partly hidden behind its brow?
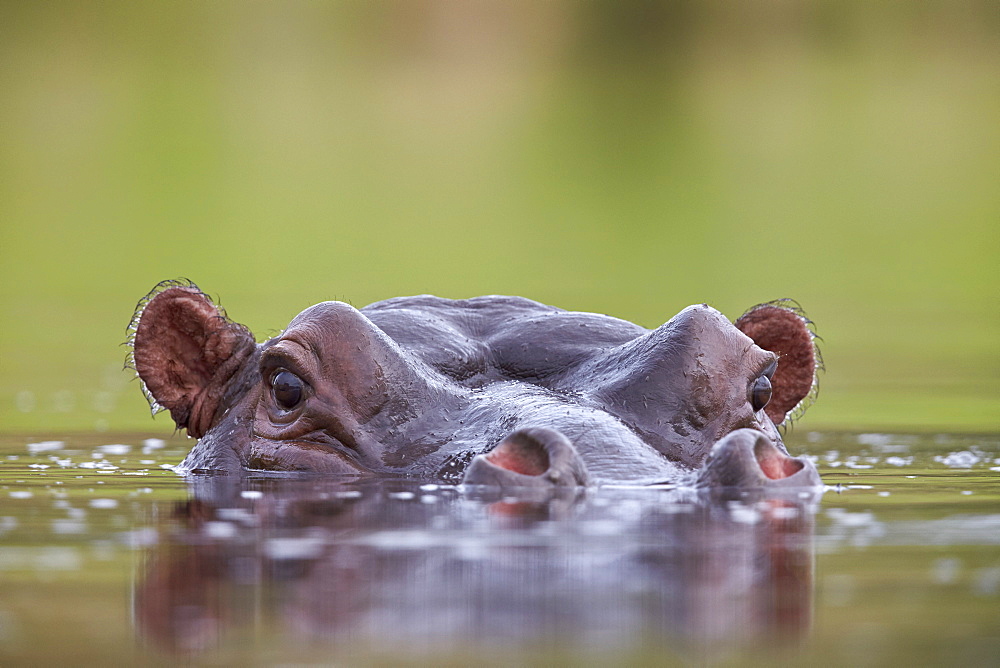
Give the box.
[735,299,822,424]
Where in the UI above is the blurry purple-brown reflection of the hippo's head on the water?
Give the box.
[133,476,820,665]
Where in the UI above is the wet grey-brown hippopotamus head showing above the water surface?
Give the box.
[129,281,820,489]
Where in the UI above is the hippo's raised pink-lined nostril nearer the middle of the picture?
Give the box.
[463,427,590,488]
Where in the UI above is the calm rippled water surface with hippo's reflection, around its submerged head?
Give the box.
[0,432,1000,665]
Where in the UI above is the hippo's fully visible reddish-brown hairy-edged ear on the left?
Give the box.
[129,281,256,438]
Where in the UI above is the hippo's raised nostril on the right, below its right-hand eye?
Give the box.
[696,429,823,488]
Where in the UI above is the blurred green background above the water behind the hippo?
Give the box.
[0,0,1000,433]
